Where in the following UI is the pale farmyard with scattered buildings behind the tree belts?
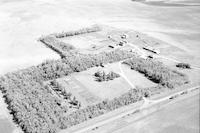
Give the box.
[40,25,198,71]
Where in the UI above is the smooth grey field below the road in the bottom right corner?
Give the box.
[113,89,200,133]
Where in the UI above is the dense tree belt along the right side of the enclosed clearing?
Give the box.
[123,57,189,88]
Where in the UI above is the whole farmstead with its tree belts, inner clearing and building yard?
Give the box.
[0,22,198,132]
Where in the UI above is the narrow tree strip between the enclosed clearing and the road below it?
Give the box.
[58,89,144,129]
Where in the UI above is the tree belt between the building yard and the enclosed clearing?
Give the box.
[37,49,134,80]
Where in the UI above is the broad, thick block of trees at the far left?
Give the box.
[0,73,63,133]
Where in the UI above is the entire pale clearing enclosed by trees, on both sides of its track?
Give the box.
[55,60,157,103]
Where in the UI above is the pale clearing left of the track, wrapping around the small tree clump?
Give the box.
[54,63,131,106]
